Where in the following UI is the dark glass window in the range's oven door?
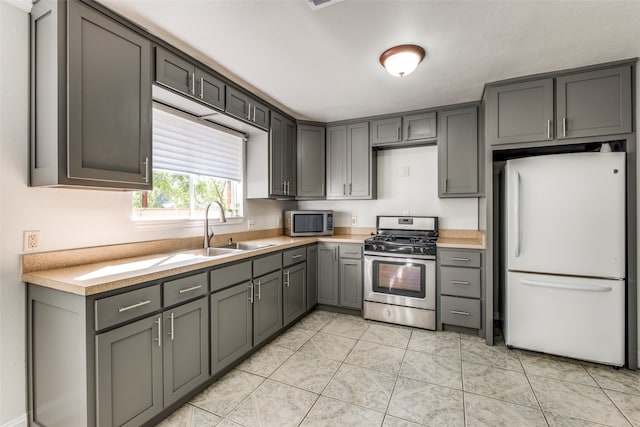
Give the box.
[372,260,426,298]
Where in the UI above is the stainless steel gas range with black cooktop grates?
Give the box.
[364,216,438,330]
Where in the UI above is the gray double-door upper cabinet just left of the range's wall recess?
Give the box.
[327,123,376,199]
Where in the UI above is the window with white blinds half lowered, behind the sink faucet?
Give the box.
[133,106,244,219]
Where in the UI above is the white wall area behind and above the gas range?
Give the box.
[299,146,478,230]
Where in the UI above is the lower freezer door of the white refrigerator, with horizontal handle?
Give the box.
[503,272,625,366]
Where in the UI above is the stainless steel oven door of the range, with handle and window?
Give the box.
[364,254,436,310]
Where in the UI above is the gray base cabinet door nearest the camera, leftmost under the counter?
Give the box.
[96,316,166,426]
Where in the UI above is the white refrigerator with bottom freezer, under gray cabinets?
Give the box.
[503,152,626,366]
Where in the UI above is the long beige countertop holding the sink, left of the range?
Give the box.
[22,234,369,296]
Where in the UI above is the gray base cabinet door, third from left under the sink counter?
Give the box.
[211,282,253,375]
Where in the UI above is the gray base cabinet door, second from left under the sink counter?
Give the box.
[162,298,209,407]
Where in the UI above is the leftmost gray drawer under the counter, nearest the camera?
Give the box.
[94,285,162,331]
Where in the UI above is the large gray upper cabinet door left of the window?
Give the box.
[67,2,152,189]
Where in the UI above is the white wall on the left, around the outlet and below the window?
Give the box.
[0,5,295,426]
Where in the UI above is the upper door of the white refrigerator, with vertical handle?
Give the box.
[505,153,626,278]
